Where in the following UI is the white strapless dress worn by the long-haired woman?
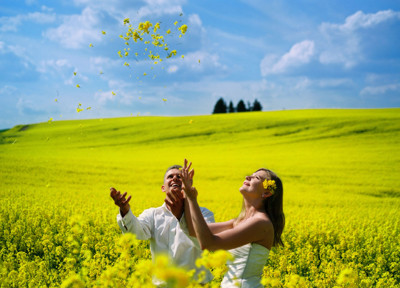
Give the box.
[221,243,269,288]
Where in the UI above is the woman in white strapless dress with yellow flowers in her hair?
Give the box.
[182,159,285,288]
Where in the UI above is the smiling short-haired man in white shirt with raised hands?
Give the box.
[110,165,214,285]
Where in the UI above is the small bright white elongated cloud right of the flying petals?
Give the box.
[260,40,314,76]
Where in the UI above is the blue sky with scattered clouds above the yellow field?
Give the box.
[0,0,400,129]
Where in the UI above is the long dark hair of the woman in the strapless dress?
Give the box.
[256,168,285,246]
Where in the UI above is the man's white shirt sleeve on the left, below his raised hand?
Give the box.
[117,209,154,240]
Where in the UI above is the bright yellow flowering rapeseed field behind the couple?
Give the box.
[0,109,400,287]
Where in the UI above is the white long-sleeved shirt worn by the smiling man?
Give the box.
[117,203,215,284]
